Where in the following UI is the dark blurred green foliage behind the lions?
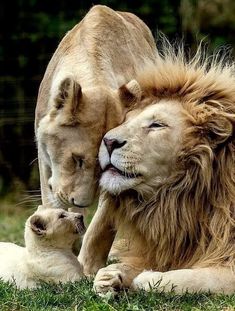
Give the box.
[0,0,235,195]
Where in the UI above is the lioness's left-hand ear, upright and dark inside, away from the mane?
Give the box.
[54,77,82,117]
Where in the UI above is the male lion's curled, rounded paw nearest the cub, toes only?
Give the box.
[93,267,123,296]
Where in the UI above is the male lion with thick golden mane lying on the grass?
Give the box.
[79,45,235,294]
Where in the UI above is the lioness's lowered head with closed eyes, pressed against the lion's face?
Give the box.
[37,77,139,208]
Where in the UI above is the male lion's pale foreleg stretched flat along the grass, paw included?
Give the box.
[132,267,235,294]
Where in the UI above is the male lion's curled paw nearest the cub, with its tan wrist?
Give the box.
[94,263,142,295]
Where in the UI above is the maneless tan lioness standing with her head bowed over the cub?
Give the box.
[35,5,156,208]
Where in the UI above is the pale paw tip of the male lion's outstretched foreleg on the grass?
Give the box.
[131,271,163,291]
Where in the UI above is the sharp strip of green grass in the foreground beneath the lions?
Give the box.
[0,280,235,311]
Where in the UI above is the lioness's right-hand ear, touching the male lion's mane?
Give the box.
[118,80,142,108]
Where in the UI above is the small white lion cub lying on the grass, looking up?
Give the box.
[0,206,85,289]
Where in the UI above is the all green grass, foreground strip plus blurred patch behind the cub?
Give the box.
[0,202,235,311]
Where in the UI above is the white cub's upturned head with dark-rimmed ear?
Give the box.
[25,206,85,248]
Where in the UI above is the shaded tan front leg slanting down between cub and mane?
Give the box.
[78,194,116,275]
